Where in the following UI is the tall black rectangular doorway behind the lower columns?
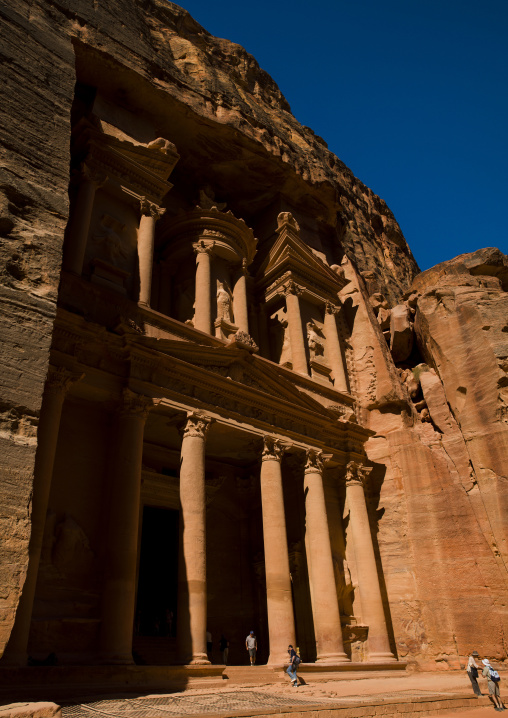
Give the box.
[136,506,179,638]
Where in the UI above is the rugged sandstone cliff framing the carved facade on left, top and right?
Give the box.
[0,0,508,667]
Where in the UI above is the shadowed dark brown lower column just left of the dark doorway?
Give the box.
[101,389,153,664]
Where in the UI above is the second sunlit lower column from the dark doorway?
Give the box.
[261,436,296,663]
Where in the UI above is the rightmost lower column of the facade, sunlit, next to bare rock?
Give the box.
[346,461,396,661]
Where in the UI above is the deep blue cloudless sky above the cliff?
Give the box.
[173,0,508,269]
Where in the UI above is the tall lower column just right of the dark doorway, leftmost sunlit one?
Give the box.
[177,412,212,664]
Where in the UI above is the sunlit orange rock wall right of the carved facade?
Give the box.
[356,249,508,666]
